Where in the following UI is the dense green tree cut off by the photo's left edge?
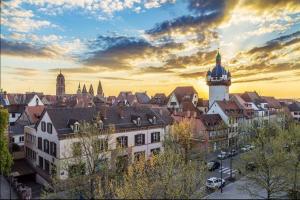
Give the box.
[0,108,13,175]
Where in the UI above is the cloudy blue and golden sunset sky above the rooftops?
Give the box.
[1,0,300,98]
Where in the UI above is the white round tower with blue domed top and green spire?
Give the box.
[206,51,231,107]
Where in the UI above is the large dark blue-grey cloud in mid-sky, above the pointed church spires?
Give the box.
[81,36,184,70]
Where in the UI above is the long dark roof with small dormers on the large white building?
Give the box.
[40,105,170,134]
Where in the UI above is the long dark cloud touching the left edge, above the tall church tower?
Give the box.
[0,38,60,58]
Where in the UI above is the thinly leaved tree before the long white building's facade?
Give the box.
[45,118,115,199]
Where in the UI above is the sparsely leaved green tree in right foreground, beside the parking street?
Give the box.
[242,123,288,199]
